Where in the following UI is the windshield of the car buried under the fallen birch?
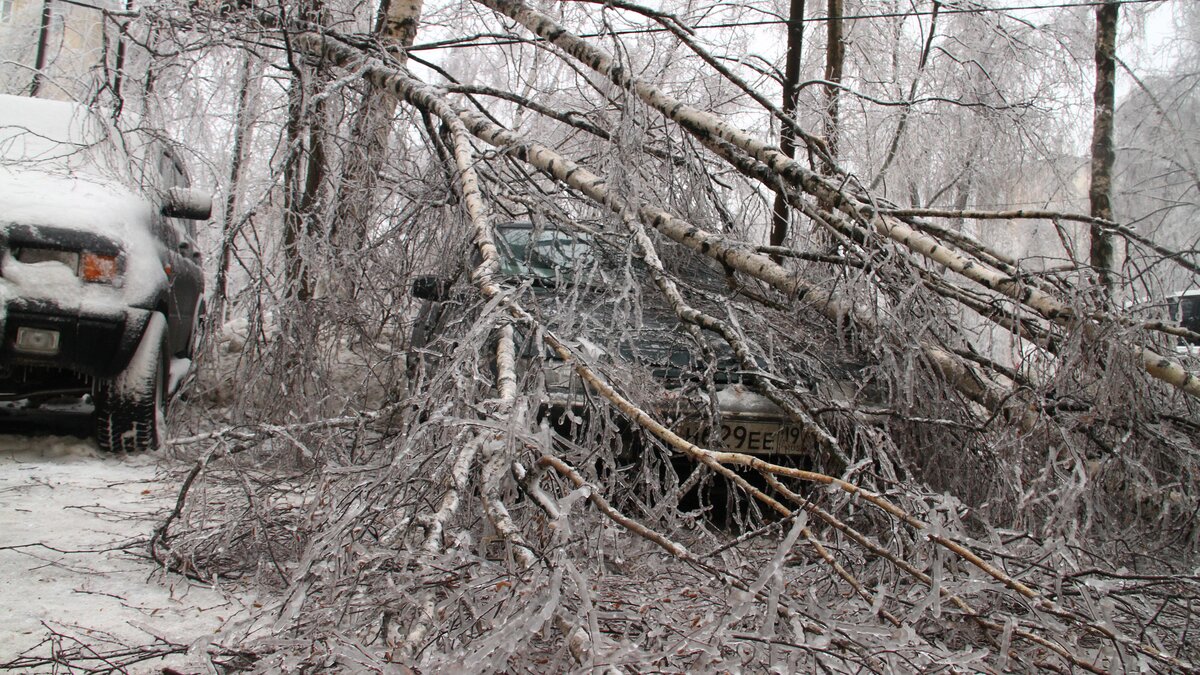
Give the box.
[497,226,592,283]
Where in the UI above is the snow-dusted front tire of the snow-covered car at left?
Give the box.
[95,312,169,453]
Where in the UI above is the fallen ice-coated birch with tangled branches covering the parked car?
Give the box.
[51,0,1200,673]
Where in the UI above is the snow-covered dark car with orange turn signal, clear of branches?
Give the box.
[0,96,211,450]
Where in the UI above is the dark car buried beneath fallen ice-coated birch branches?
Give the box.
[409,222,805,455]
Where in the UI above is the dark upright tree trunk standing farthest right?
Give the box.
[1088,0,1120,294]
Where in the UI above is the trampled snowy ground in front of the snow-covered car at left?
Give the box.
[0,411,245,673]
